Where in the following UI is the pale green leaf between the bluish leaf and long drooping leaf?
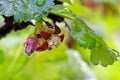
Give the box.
[49,5,76,20]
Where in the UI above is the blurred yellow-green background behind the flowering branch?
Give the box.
[0,0,120,80]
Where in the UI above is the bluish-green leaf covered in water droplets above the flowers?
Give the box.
[0,0,54,22]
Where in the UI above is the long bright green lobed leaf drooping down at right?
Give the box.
[71,18,119,67]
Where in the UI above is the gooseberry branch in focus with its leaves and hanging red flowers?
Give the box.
[0,0,119,66]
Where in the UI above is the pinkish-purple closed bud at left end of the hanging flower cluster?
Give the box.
[25,37,37,56]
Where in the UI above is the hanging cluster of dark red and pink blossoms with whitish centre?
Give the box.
[25,22,64,56]
